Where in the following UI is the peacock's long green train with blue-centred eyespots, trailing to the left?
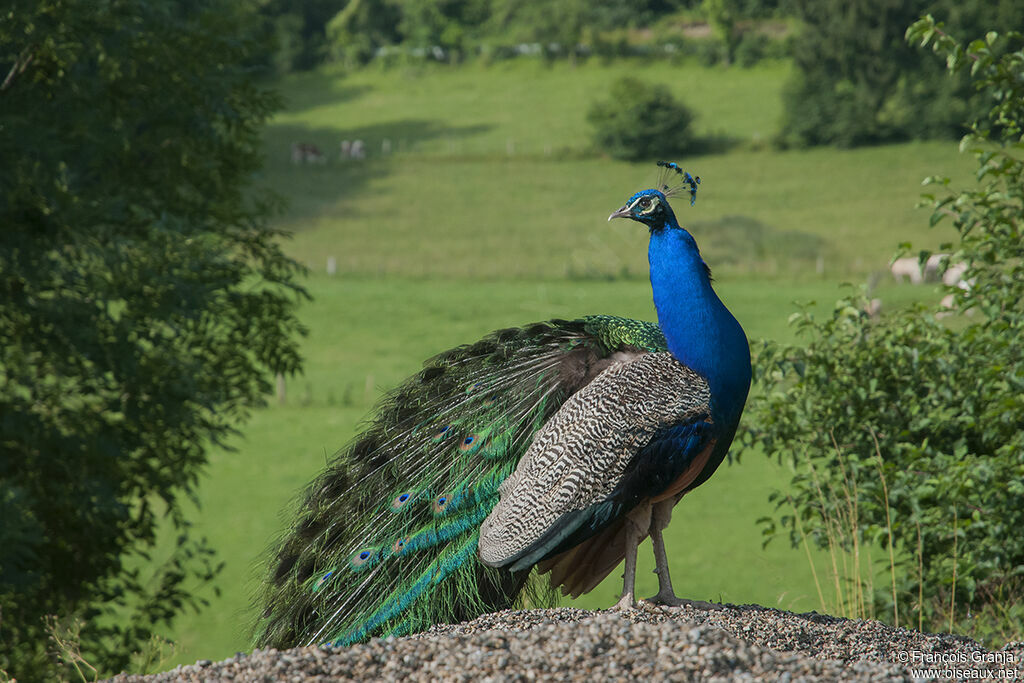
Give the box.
[256,315,668,647]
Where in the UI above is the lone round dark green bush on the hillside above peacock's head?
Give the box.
[587,77,694,161]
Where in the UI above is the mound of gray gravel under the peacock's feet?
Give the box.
[105,605,1024,683]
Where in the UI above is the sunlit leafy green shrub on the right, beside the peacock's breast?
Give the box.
[745,17,1024,638]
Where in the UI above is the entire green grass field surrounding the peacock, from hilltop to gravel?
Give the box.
[149,57,971,667]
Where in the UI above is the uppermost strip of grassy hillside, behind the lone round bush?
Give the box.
[268,60,790,158]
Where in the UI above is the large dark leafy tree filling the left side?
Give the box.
[0,0,305,680]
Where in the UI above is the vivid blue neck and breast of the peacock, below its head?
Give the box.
[647,214,751,428]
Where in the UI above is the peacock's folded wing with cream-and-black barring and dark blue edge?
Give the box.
[479,352,714,583]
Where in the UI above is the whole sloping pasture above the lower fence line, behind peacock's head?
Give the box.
[266,58,970,280]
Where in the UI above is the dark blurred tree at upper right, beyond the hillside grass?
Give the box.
[780,0,1024,147]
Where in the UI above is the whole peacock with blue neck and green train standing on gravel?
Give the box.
[255,162,751,648]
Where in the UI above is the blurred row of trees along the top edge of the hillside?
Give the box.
[261,0,779,71]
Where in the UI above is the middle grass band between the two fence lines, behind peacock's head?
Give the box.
[275,148,959,280]
